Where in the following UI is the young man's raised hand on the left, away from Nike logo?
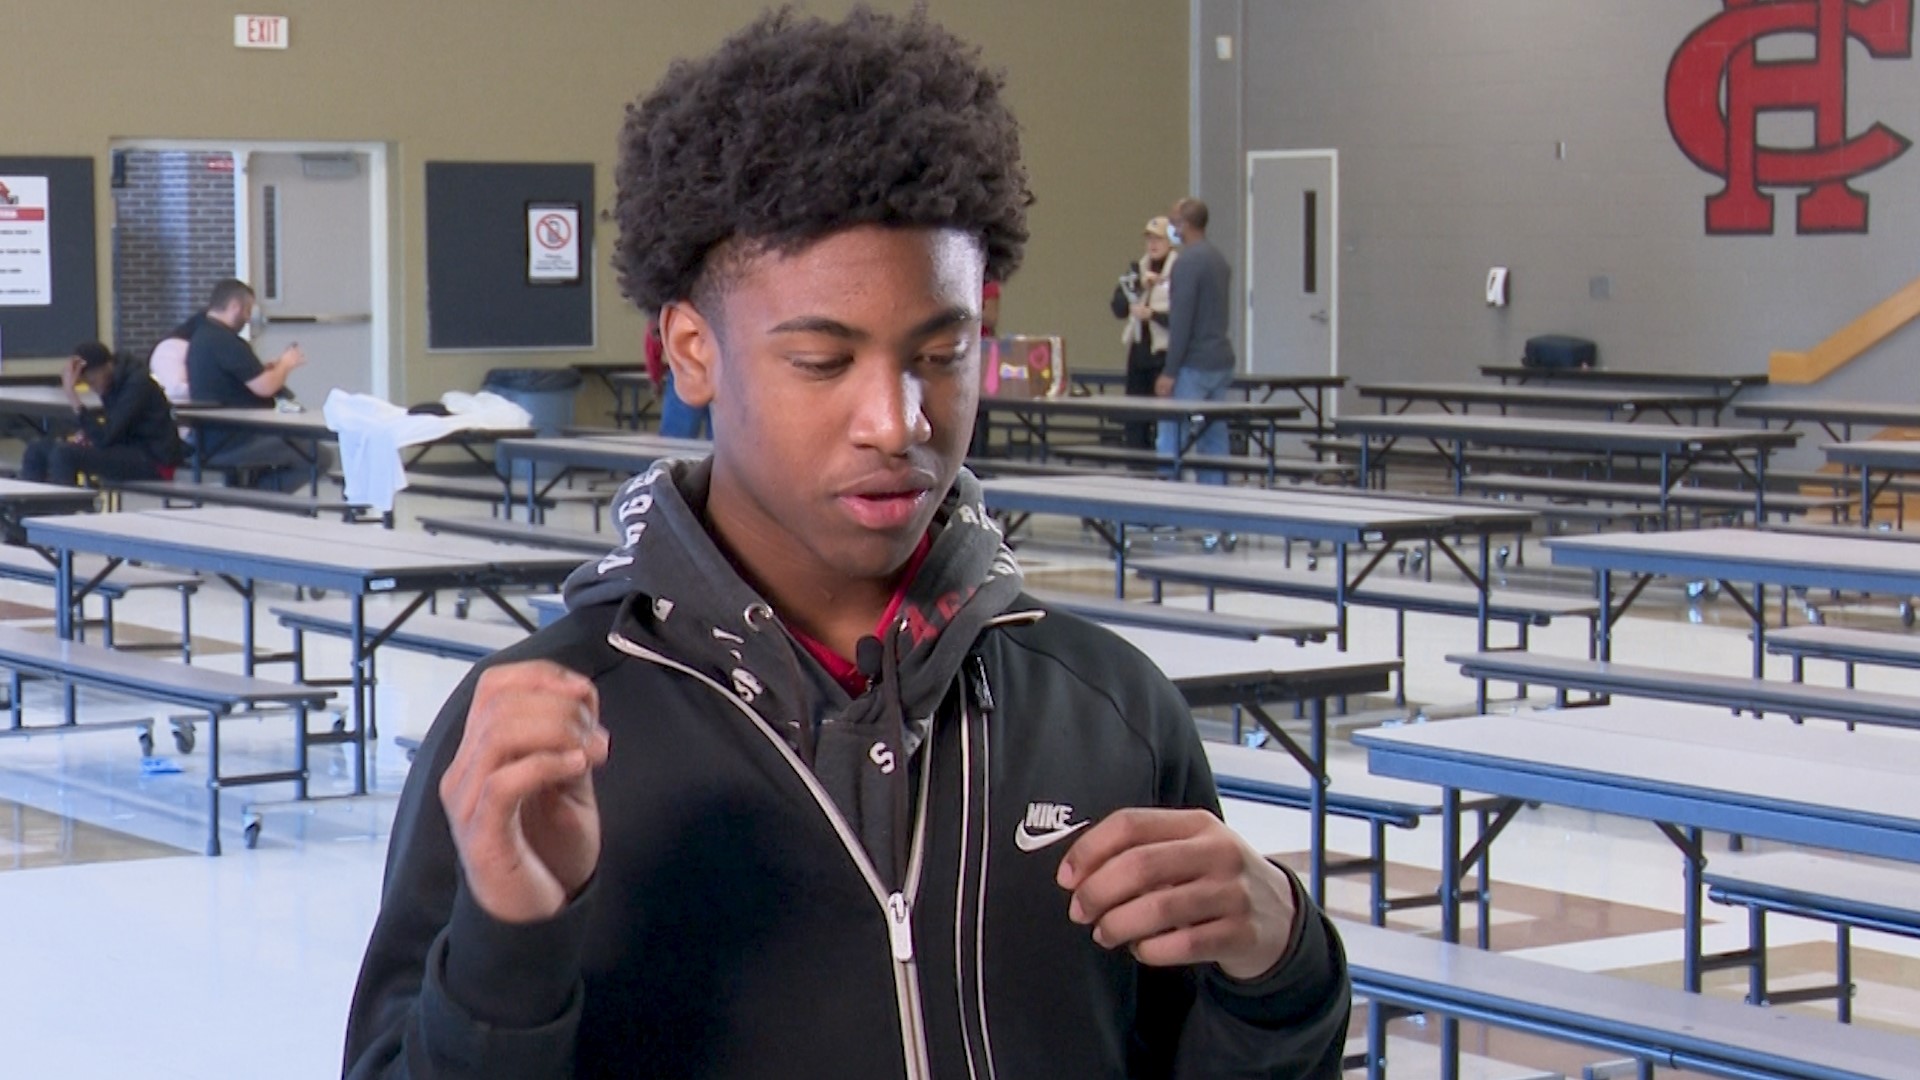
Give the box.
[440,661,609,922]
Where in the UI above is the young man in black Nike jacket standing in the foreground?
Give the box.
[346,6,1350,1078]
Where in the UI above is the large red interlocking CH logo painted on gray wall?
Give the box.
[1667,0,1914,236]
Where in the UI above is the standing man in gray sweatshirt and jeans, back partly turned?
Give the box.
[1154,198,1235,484]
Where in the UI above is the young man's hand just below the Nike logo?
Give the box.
[1054,809,1294,980]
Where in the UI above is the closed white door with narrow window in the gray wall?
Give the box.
[1246,150,1340,375]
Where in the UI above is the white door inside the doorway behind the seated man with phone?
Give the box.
[246,150,374,401]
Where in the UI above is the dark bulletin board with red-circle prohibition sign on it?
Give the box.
[426,161,595,350]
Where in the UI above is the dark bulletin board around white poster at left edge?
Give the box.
[0,158,100,359]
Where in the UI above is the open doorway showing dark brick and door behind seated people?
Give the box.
[113,140,394,399]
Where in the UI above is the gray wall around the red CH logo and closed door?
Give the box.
[1192,0,1920,417]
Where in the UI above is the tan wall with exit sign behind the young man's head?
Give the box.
[0,0,1187,400]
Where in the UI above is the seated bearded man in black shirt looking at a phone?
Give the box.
[186,279,324,486]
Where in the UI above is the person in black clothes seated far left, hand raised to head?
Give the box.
[19,342,182,486]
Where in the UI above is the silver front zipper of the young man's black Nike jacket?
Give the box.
[607,630,929,1080]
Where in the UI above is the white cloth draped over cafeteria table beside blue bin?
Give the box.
[321,390,534,513]
